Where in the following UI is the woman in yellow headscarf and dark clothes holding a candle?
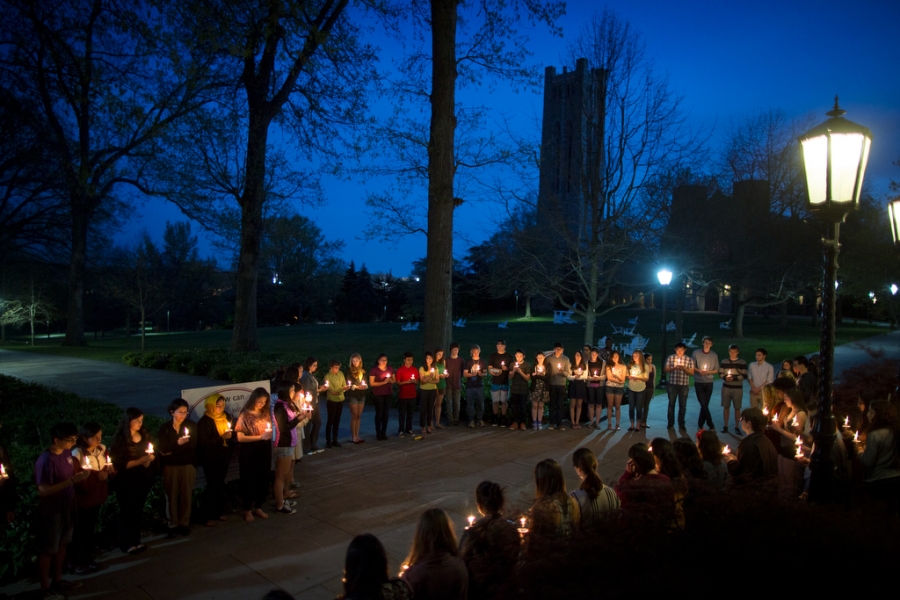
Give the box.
[197,394,234,527]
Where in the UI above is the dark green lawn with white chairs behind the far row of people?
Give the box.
[4,309,887,366]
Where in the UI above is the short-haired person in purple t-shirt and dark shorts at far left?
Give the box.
[34,423,90,598]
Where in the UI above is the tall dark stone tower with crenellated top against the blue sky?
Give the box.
[538,58,605,230]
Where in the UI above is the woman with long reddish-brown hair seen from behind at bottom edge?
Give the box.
[402,508,469,600]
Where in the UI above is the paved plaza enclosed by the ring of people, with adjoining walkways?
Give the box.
[0,333,900,600]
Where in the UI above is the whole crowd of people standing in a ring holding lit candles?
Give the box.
[0,340,900,598]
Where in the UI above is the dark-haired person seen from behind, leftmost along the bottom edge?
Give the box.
[338,533,412,600]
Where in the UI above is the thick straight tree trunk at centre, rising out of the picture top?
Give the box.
[423,0,458,351]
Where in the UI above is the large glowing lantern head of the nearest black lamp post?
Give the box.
[799,96,872,220]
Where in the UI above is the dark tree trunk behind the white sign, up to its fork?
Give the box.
[231,112,271,352]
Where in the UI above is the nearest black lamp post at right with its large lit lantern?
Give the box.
[798,96,872,503]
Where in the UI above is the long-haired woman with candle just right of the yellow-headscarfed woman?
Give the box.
[234,390,270,523]
